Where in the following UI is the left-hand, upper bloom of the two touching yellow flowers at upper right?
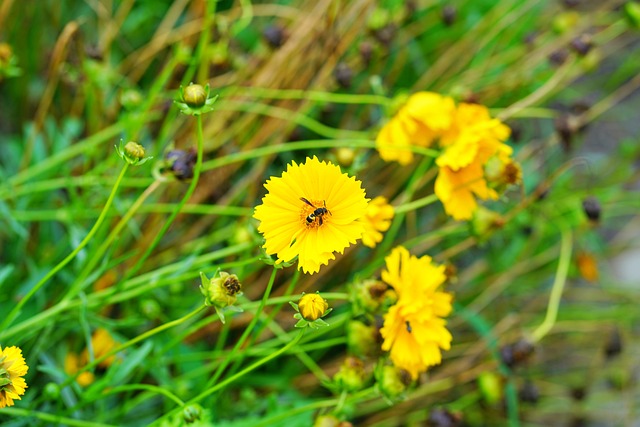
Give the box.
[376,92,455,165]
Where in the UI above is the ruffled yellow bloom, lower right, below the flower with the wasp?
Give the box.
[380,246,453,379]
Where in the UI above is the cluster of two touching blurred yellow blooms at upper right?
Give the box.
[377,92,521,220]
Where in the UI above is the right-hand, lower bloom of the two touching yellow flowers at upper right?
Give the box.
[435,103,512,220]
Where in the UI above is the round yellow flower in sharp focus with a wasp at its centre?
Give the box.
[253,156,367,273]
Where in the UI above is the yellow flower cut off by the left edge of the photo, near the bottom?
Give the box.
[0,346,29,408]
